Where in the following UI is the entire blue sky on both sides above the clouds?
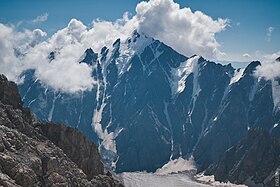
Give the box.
[0,0,280,60]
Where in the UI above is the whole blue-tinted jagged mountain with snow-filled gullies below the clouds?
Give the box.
[19,32,280,177]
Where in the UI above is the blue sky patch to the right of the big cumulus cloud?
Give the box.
[184,0,280,53]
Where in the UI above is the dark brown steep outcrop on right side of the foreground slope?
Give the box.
[41,123,104,179]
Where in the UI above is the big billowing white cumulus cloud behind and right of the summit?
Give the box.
[135,0,228,59]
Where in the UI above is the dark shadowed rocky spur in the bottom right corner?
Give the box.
[205,127,280,186]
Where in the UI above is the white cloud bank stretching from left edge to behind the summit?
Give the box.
[0,0,228,93]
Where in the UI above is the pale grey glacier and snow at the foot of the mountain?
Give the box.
[119,157,246,187]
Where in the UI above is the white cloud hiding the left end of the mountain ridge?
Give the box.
[0,20,94,93]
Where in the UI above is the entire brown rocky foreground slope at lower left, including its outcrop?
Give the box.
[0,75,122,187]
